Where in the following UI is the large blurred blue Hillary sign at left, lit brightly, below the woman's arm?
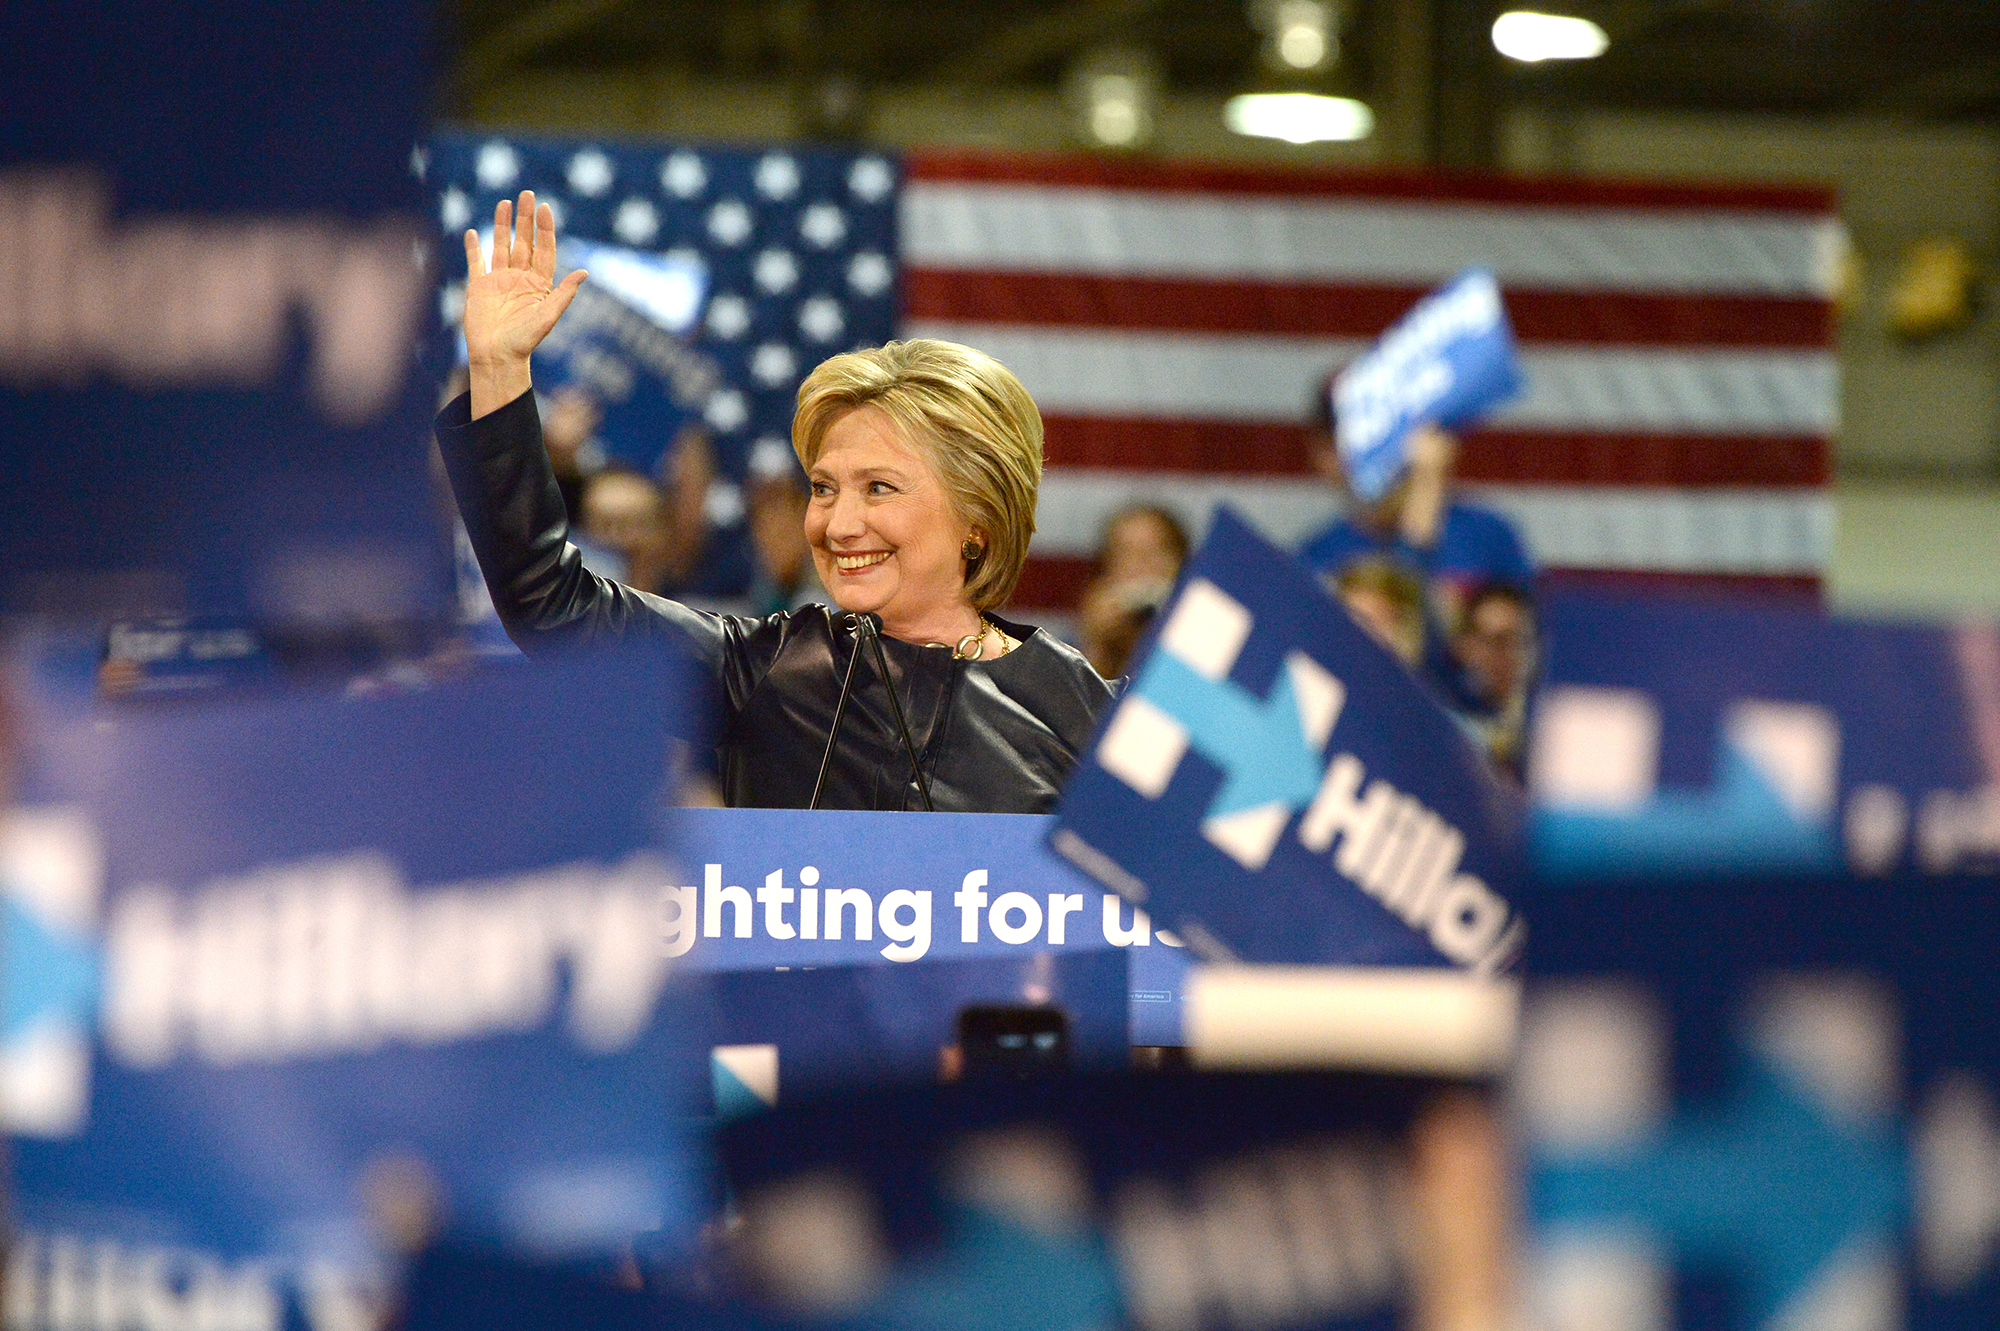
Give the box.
[0,648,710,1329]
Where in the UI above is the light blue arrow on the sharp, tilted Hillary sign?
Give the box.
[1134,652,1324,817]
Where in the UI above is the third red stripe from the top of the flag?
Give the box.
[1042,416,1830,488]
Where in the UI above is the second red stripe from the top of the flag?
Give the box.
[902,268,1834,350]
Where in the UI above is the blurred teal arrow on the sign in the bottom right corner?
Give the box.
[1530,1063,1908,1327]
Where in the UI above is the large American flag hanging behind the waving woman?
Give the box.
[434,131,1844,610]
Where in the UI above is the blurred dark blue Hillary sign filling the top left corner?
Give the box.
[0,0,452,630]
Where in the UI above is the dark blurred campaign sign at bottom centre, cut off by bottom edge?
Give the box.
[720,1073,1438,1331]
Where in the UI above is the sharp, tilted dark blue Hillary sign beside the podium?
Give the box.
[1050,512,1522,969]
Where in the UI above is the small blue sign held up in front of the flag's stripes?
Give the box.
[1332,268,1522,502]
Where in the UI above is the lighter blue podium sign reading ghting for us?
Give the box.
[662,809,1188,1045]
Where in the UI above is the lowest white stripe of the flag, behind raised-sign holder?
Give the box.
[1032,468,1834,574]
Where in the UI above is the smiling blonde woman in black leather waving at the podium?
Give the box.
[436,192,1112,813]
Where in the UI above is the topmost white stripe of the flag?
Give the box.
[900,180,1844,296]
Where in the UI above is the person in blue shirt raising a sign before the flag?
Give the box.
[1300,367,1534,624]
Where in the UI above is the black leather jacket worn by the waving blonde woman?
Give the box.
[436,394,1112,813]
